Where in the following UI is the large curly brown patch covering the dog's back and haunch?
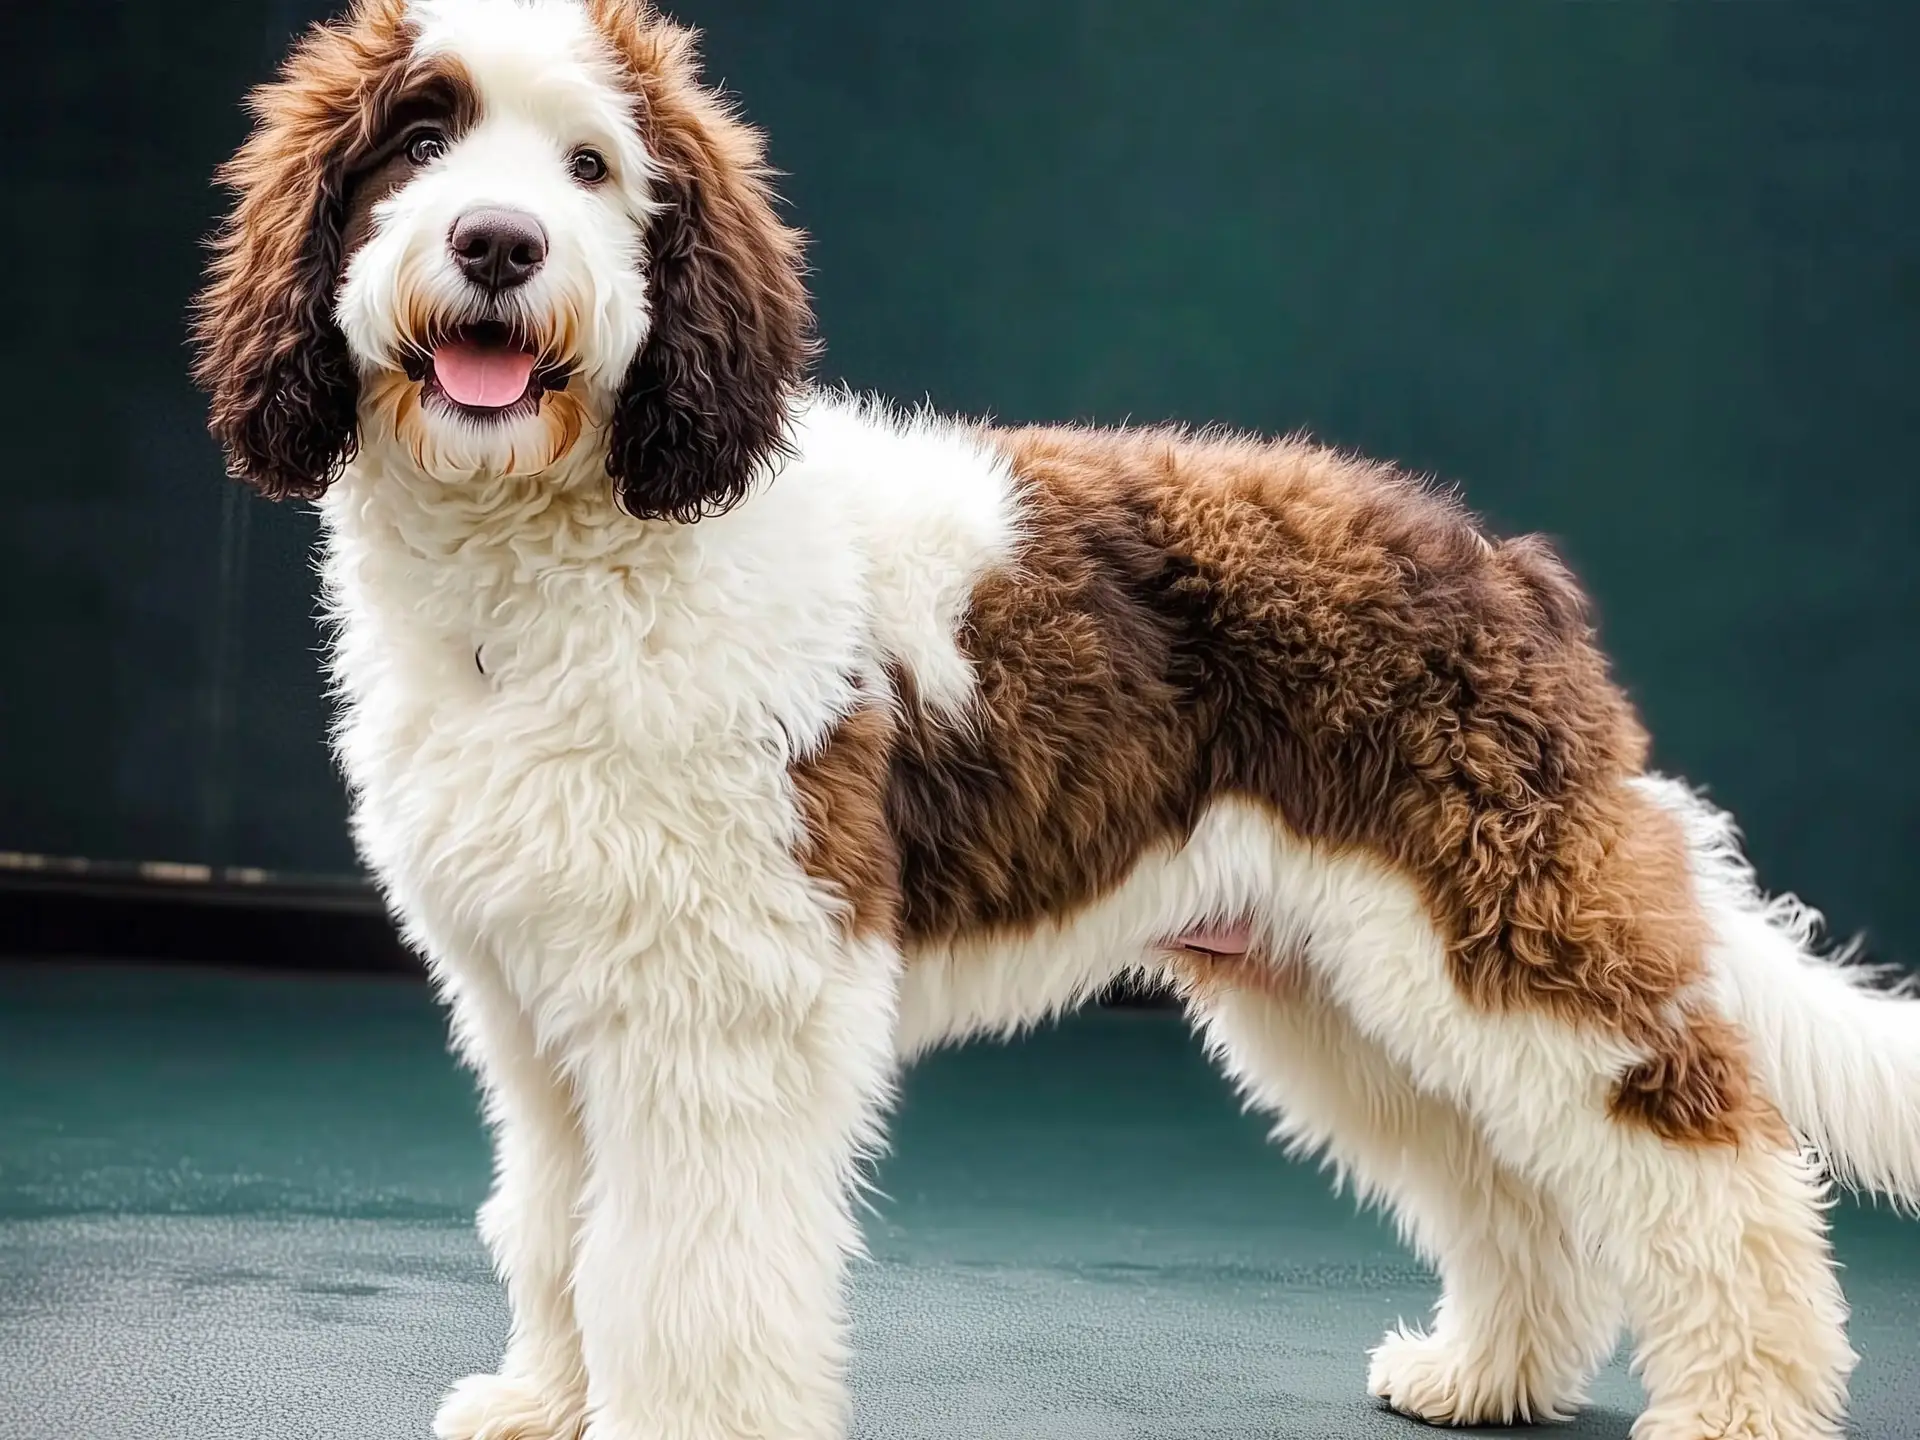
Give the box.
[844,420,1778,1142]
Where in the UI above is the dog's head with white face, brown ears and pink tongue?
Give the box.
[196,0,810,520]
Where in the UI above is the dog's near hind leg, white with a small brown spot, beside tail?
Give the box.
[1286,856,1853,1440]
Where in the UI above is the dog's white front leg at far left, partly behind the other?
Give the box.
[434,960,588,1440]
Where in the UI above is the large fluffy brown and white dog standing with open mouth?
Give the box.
[194,0,1920,1440]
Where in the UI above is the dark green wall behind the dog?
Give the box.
[0,0,1920,971]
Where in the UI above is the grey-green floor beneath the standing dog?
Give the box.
[0,968,1920,1440]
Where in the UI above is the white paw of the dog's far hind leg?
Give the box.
[1367,1327,1582,1425]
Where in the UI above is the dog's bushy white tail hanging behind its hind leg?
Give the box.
[1644,780,1920,1212]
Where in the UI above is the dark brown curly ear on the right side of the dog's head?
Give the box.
[593,0,814,522]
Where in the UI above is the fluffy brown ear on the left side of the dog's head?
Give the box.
[194,0,409,499]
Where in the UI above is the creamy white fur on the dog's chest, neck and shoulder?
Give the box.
[311,401,1014,1029]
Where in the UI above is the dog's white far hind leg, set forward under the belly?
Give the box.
[1179,960,1619,1425]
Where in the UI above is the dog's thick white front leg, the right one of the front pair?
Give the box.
[568,939,897,1440]
